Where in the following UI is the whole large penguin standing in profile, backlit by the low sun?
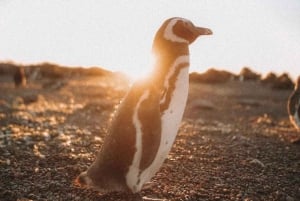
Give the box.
[76,17,212,193]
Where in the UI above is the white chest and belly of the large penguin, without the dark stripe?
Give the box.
[136,55,189,188]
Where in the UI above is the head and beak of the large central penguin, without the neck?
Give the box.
[161,17,212,44]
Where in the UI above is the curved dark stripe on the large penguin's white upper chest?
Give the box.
[160,62,189,113]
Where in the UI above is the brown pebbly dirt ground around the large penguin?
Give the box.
[0,76,300,201]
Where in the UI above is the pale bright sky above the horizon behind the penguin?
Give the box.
[0,0,300,79]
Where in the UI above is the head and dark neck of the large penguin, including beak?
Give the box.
[152,17,212,83]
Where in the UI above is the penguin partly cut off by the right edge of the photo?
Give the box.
[288,76,300,130]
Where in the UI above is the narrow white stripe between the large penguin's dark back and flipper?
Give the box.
[126,90,150,192]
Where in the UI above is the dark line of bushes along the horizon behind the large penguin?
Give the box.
[0,63,294,89]
